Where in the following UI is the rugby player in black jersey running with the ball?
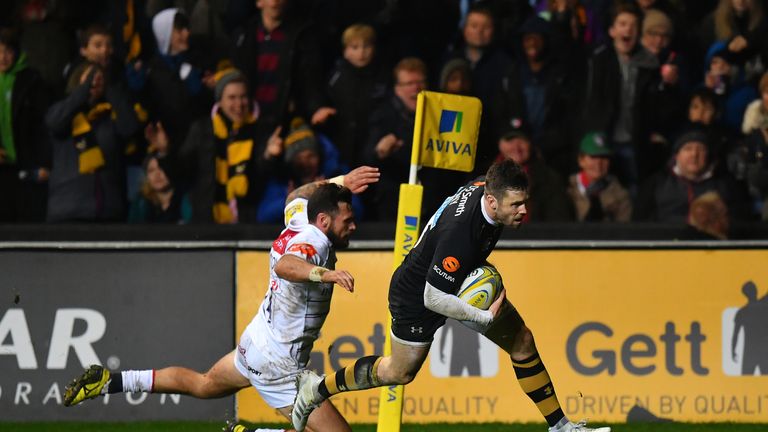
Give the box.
[292,160,610,432]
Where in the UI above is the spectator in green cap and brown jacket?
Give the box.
[568,132,632,222]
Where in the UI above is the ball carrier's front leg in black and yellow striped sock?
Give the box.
[483,301,611,432]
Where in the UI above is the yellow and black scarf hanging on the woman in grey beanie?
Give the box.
[212,110,256,224]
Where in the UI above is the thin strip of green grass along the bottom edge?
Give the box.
[0,422,768,432]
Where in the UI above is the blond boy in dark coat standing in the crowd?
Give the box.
[328,24,387,166]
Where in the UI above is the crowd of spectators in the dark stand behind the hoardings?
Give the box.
[0,0,768,238]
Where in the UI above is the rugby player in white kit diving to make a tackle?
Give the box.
[64,167,379,432]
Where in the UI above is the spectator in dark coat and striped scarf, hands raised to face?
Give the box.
[45,62,139,222]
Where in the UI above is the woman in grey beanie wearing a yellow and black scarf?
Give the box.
[171,69,283,224]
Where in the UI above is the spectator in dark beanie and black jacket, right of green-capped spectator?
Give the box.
[634,129,753,225]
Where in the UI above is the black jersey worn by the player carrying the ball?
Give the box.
[389,181,503,316]
